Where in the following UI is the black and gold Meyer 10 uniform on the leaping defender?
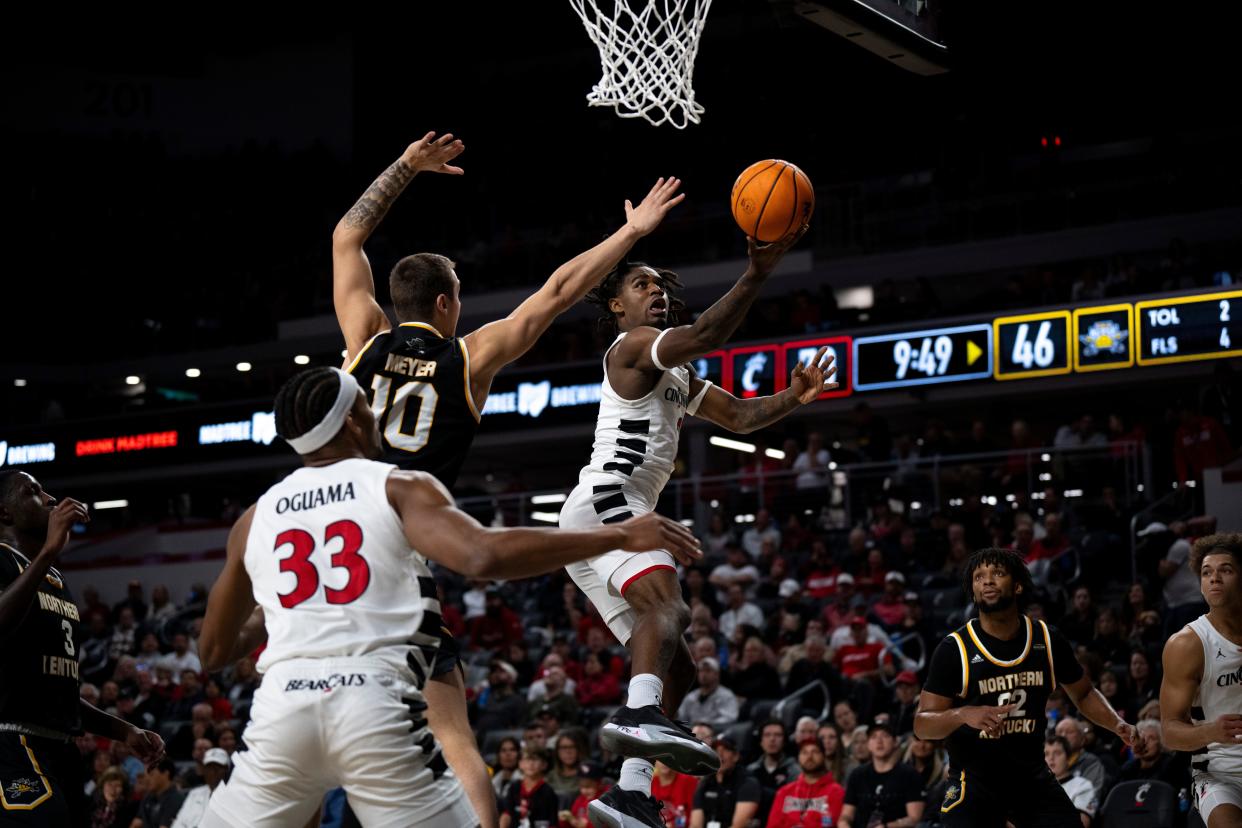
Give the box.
[349,322,479,675]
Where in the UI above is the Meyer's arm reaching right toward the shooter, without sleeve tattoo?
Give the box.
[466,178,686,392]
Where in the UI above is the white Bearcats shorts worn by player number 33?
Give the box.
[202,658,478,828]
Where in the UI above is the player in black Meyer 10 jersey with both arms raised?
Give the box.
[332,133,684,828]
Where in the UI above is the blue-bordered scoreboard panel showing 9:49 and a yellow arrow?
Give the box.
[853,324,992,391]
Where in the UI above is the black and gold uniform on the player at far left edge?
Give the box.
[0,544,88,826]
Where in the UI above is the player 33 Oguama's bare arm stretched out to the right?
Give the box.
[387,472,703,583]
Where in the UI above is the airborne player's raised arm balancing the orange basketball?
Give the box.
[614,225,807,371]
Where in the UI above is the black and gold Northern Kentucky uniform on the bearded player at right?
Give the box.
[924,614,1083,828]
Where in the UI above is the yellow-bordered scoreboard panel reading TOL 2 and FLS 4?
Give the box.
[1134,290,1242,365]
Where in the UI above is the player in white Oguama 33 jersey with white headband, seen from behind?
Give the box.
[199,367,700,828]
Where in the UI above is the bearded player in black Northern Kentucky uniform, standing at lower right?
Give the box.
[914,549,1135,828]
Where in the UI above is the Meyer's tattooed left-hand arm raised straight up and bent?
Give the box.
[332,133,465,365]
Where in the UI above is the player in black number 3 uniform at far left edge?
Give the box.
[0,470,164,828]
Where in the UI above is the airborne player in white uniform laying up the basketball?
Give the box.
[560,227,836,828]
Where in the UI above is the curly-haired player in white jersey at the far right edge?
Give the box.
[1160,533,1242,828]
